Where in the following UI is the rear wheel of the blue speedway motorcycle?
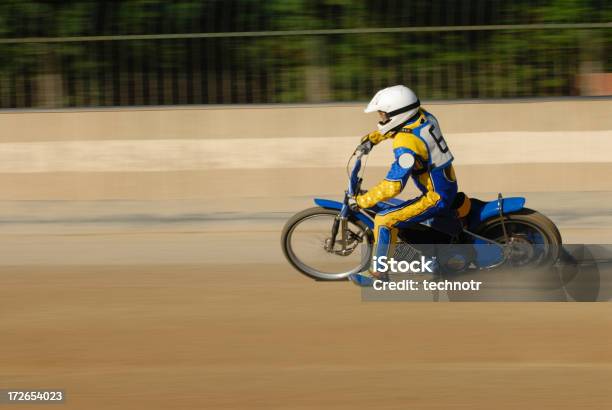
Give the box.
[476,208,561,268]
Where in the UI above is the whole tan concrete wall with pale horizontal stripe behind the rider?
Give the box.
[0,99,612,199]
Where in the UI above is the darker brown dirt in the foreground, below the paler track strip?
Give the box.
[0,264,612,409]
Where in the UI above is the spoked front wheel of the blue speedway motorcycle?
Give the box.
[281,207,373,280]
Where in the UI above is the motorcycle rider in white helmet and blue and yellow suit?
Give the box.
[349,85,457,286]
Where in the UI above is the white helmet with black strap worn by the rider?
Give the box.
[364,85,421,134]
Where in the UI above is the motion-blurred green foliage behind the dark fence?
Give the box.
[0,0,612,107]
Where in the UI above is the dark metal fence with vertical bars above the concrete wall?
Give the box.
[0,0,612,108]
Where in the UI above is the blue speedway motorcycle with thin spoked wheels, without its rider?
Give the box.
[281,148,561,281]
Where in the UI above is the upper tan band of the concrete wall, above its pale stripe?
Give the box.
[0,99,612,142]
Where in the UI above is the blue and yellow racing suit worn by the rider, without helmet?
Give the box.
[355,109,457,264]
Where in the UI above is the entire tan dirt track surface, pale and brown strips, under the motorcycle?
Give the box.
[0,193,612,409]
